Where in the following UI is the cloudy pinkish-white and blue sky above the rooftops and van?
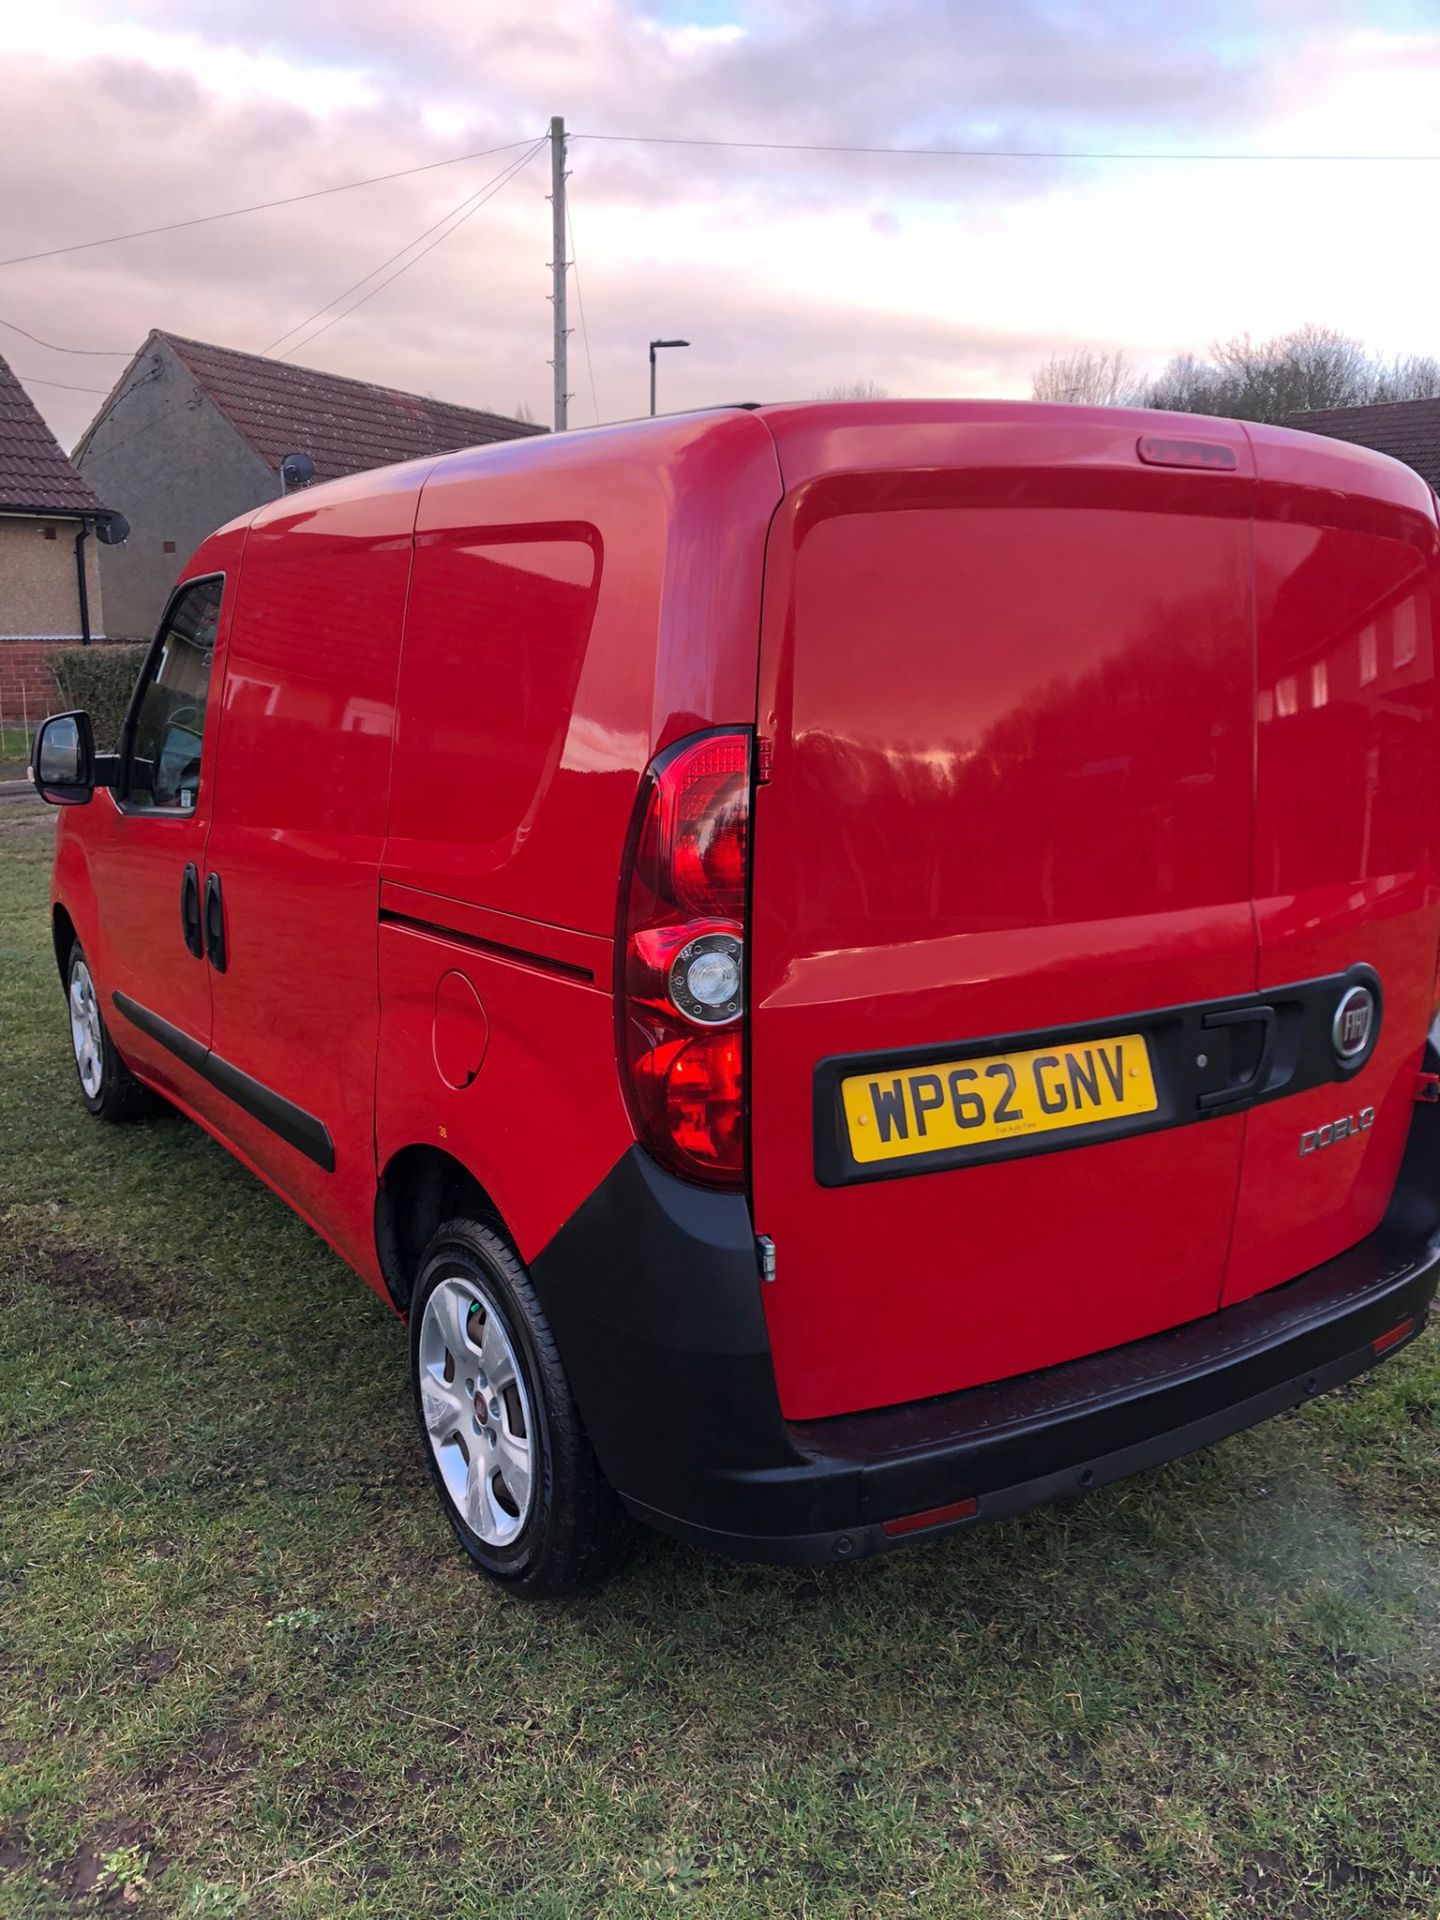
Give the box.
[0,0,1440,445]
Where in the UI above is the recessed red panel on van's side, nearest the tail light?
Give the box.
[390,526,601,870]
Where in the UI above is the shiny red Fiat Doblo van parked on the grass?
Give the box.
[35,401,1440,1594]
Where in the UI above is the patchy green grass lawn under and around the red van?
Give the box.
[0,801,1440,1920]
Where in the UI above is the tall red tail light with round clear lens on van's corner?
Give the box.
[616,730,751,1187]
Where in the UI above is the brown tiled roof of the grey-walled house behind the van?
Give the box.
[156,332,543,480]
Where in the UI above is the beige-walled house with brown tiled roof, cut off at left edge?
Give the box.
[0,359,109,726]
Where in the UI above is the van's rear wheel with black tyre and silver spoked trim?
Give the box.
[409,1219,634,1599]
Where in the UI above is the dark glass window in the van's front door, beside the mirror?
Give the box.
[121,580,221,812]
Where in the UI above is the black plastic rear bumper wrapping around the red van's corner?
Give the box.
[534,1108,1440,1563]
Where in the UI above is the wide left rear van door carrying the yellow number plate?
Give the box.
[751,407,1256,1419]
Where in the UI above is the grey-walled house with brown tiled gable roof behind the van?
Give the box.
[75,328,545,639]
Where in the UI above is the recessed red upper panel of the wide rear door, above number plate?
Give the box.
[793,507,1250,947]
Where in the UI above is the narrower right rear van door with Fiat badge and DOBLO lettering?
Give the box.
[1225,428,1440,1302]
